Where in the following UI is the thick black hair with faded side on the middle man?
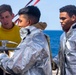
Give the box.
[18,5,41,23]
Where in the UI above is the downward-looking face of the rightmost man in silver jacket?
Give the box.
[60,12,75,32]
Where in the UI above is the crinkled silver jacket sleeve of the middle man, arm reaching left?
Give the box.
[1,33,48,74]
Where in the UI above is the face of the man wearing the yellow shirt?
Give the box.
[0,11,14,29]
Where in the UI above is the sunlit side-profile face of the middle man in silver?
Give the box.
[18,15,30,28]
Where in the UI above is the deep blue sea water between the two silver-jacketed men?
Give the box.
[44,30,63,57]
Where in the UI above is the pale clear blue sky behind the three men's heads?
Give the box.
[0,0,76,30]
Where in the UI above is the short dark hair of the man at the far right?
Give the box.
[59,5,76,17]
